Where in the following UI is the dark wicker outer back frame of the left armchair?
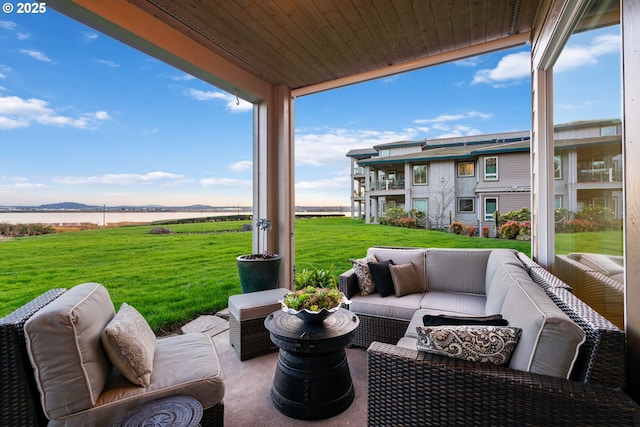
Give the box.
[0,289,65,426]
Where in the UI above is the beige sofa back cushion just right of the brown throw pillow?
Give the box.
[426,248,493,296]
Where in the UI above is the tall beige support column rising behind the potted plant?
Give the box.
[253,86,295,289]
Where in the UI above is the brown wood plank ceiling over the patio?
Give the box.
[130,0,540,89]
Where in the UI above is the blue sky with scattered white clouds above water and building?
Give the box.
[0,9,620,207]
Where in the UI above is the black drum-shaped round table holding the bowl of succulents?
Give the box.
[264,309,360,420]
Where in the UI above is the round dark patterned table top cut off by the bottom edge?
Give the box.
[114,396,202,427]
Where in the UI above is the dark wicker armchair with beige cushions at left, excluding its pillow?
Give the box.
[0,283,224,426]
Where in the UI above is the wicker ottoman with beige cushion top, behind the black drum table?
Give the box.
[229,288,290,360]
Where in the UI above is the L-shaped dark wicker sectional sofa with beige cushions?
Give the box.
[340,248,640,425]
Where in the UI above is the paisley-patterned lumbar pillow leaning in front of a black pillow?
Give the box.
[416,326,522,366]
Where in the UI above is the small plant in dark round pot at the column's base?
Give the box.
[236,218,282,293]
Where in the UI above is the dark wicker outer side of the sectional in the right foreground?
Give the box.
[367,342,640,426]
